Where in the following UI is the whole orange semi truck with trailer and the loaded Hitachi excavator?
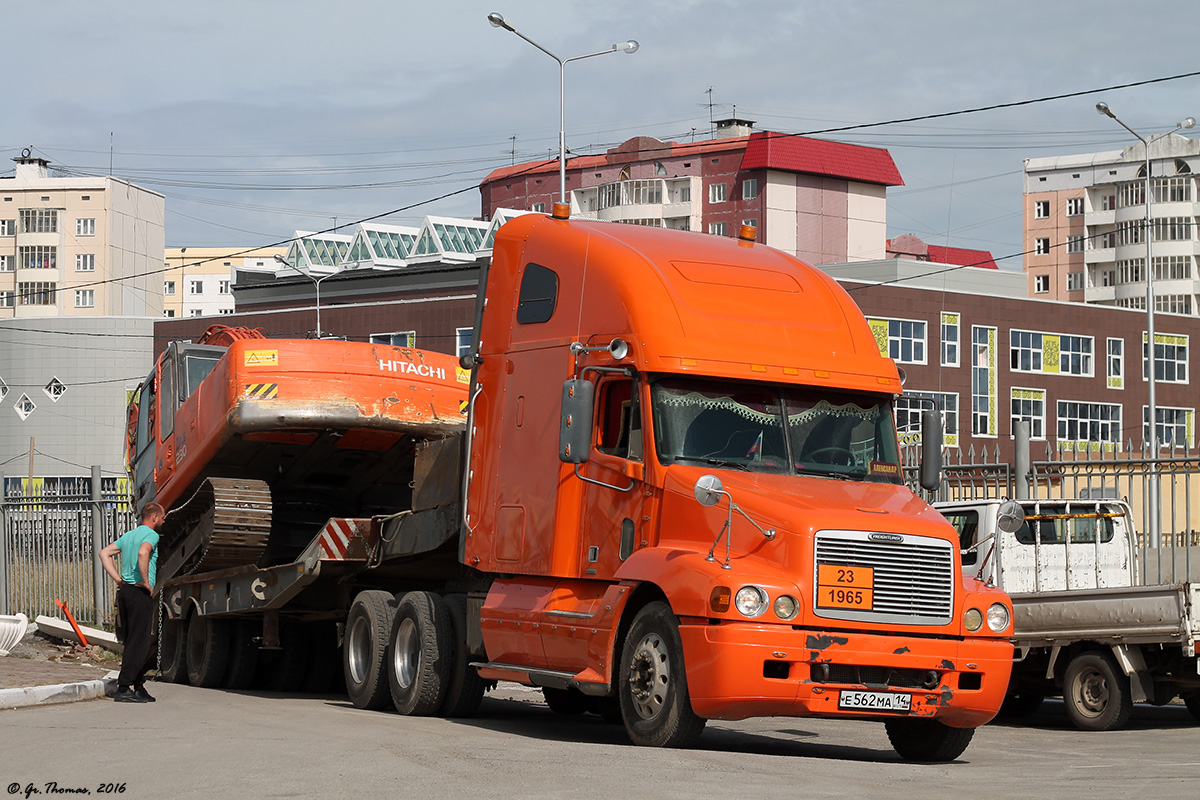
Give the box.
[128,207,1013,760]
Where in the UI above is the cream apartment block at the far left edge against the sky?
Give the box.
[0,154,164,319]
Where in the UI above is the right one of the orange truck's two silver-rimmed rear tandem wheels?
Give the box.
[388,591,454,716]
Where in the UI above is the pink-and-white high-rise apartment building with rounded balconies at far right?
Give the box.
[1024,134,1200,314]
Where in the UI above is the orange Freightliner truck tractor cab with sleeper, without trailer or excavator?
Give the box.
[461,210,1013,760]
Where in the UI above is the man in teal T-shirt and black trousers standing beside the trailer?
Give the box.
[98,503,167,703]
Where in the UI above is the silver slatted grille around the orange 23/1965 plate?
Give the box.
[812,530,955,625]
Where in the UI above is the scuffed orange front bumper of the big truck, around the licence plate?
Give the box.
[679,622,1013,728]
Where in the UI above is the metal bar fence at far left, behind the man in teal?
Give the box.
[0,469,137,626]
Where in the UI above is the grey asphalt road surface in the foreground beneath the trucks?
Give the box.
[0,684,1200,800]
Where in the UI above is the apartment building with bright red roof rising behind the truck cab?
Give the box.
[479,119,904,264]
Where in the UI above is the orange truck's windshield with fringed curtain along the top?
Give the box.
[652,375,901,483]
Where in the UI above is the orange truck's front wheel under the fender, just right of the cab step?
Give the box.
[617,601,706,747]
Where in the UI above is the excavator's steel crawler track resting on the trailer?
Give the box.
[158,477,271,583]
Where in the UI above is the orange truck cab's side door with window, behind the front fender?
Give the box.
[580,374,646,579]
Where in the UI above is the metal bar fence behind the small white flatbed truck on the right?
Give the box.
[904,441,1200,584]
